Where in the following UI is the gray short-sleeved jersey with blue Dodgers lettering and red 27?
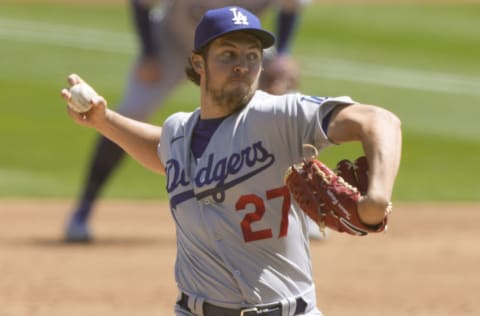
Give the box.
[158,91,353,315]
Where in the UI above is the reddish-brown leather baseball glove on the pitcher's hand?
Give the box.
[285,156,391,236]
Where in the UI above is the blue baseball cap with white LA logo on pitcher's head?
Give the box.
[194,7,275,52]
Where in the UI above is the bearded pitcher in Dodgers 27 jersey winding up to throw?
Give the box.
[62,6,401,316]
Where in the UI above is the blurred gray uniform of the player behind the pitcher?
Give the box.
[117,0,305,121]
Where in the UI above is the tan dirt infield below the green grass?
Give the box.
[0,200,480,316]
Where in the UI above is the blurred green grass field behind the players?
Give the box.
[0,2,480,201]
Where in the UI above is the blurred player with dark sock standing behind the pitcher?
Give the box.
[64,0,310,242]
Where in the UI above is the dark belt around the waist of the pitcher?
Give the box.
[177,293,307,316]
